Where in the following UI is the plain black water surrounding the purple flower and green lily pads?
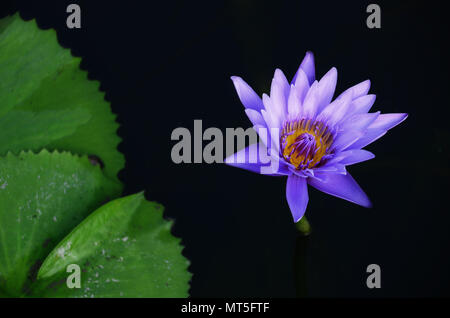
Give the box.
[0,0,450,297]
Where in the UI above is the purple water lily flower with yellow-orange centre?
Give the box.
[225,52,408,222]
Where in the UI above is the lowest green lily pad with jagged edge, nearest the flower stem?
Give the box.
[34,193,191,297]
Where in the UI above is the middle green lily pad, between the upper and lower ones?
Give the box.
[0,150,120,296]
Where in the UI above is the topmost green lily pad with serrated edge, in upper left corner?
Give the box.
[0,14,124,181]
